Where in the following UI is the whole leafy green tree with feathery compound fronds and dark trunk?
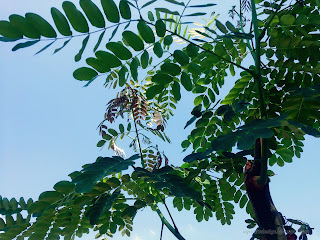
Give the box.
[0,0,319,239]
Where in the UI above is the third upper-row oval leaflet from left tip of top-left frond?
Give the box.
[26,13,57,38]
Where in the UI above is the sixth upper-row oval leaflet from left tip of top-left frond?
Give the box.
[80,0,105,28]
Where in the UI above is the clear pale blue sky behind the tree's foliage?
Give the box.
[0,0,320,240]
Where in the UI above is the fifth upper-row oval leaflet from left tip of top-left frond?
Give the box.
[62,1,89,33]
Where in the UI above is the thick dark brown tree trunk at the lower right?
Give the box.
[244,139,286,240]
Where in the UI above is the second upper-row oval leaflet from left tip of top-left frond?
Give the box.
[9,14,40,38]
